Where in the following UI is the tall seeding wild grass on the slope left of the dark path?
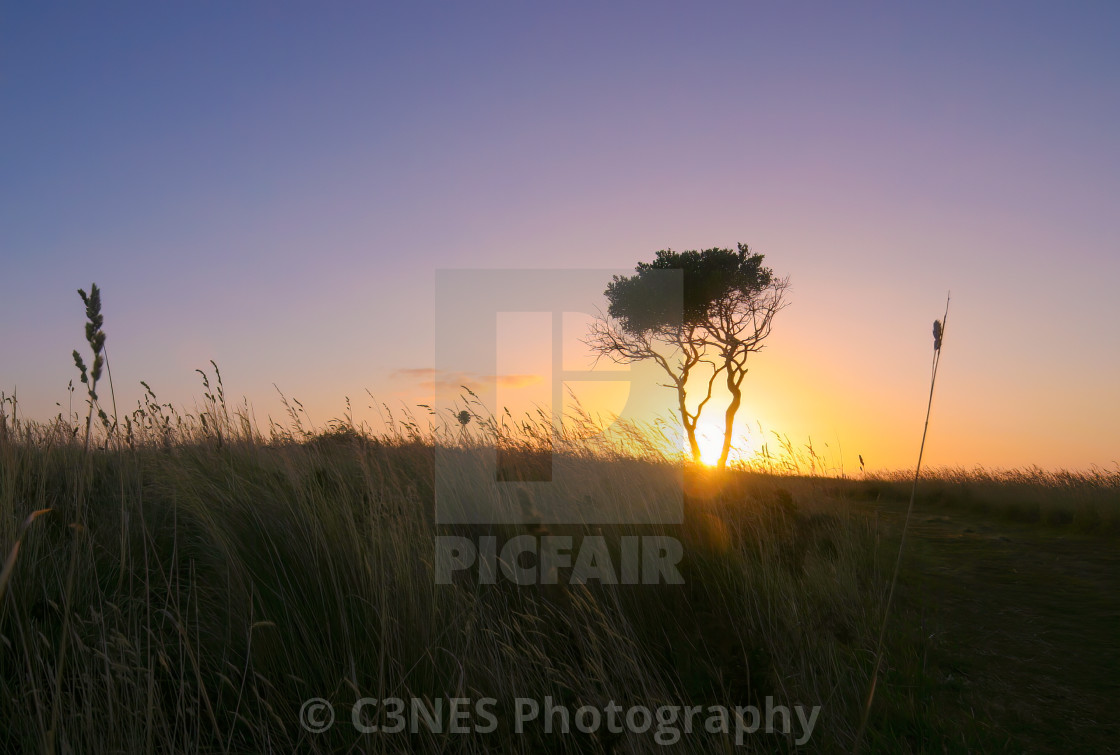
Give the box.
[0,291,1118,753]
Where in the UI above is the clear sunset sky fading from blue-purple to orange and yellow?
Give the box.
[0,1,1120,470]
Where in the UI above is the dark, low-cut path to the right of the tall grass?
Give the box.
[880,501,1120,753]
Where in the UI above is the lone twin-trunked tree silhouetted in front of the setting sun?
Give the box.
[585,244,790,468]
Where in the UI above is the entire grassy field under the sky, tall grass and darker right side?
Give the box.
[0,393,1120,753]
